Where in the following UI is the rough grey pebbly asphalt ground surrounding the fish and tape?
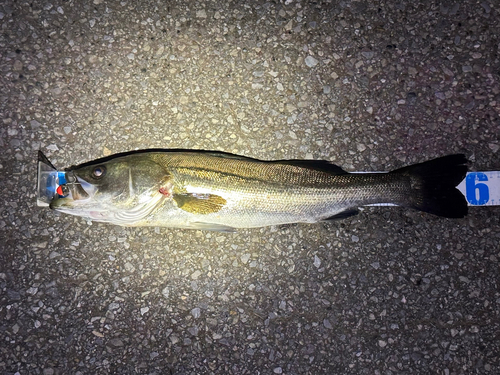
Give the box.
[0,0,500,375]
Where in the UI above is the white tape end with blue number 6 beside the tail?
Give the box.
[457,171,500,206]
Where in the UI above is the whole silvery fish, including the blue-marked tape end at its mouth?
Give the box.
[38,149,468,232]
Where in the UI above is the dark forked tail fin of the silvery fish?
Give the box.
[391,154,468,218]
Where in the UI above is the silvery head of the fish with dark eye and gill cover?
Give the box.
[50,155,170,225]
